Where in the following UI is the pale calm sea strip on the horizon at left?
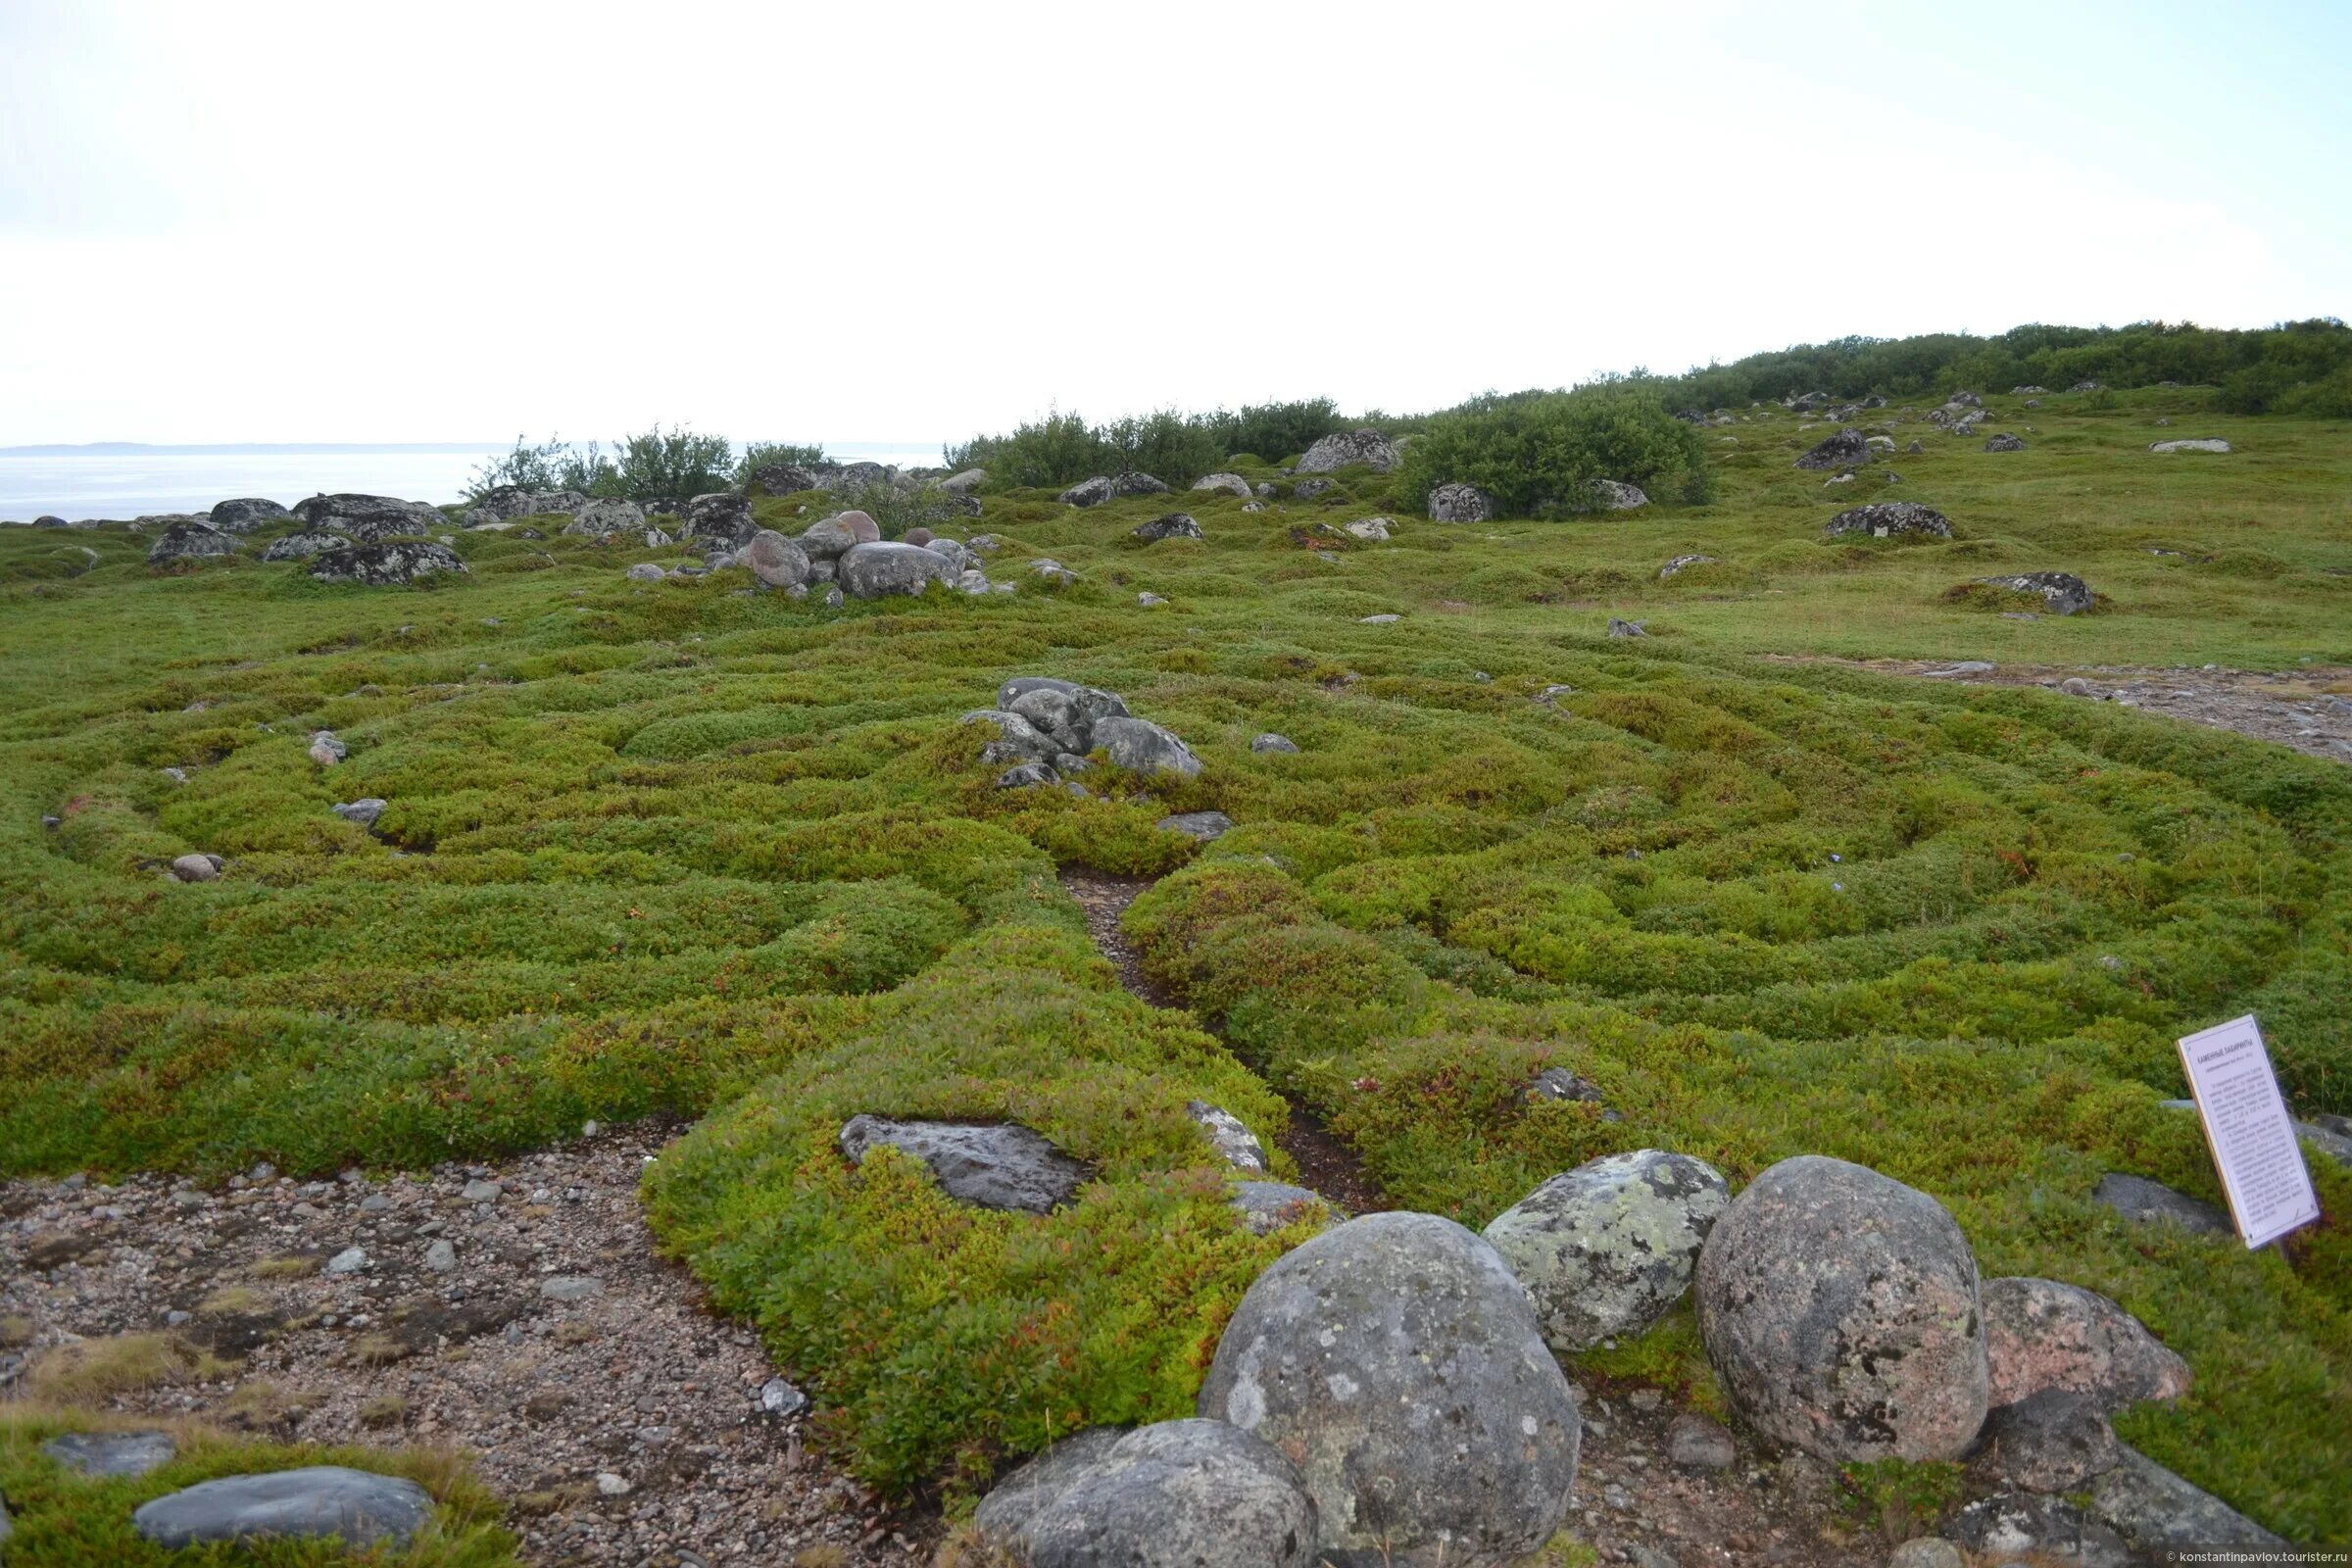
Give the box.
[0,442,939,522]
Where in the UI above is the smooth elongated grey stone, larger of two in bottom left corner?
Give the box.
[131,1464,433,1549]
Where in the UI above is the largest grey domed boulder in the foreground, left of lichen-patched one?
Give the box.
[1200,1213,1581,1568]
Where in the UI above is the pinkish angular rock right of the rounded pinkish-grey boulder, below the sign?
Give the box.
[1983,1279,2189,1415]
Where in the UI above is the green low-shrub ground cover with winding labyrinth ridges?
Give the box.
[0,385,2352,1543]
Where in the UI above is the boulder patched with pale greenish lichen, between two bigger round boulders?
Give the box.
[1487,1150,1731,1349]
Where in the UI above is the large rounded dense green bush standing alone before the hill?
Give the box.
[1399,388,1715,517]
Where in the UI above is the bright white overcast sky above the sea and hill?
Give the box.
[0,0,2352,444]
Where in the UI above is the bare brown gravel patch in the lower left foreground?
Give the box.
[0,1126,939,1568]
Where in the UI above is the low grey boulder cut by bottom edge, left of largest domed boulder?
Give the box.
[983,1420,1317,1568]
